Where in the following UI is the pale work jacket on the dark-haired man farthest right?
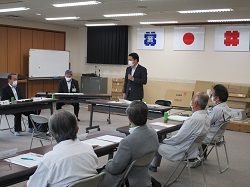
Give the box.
[204,102,231,143]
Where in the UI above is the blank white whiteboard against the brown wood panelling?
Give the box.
[29,49,69,78]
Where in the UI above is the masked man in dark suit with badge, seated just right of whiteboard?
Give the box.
[56,70,80,121]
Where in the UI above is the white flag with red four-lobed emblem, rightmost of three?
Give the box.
[214,26,250,51]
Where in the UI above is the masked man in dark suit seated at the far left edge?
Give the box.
[1,73,36,136]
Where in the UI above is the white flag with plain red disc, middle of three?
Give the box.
[174,27,205,51]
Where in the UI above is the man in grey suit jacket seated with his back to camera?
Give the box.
[101,101,159,187]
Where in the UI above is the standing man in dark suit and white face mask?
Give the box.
[123,53,147,101]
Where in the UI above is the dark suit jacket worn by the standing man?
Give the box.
[123,64,147,101]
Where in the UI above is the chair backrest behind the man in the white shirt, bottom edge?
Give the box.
[68,172,106,187]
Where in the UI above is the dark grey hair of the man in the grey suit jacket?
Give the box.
[126,101,148,126]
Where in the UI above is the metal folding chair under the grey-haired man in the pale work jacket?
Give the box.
[164,134,206,187]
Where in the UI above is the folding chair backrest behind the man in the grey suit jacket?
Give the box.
[118,151,155,187]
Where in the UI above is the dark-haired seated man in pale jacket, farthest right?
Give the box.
[202,84,231,158]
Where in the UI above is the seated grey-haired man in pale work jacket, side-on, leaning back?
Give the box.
[150,92,210,172]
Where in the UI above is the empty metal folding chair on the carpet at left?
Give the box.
[29,114,54,149]
